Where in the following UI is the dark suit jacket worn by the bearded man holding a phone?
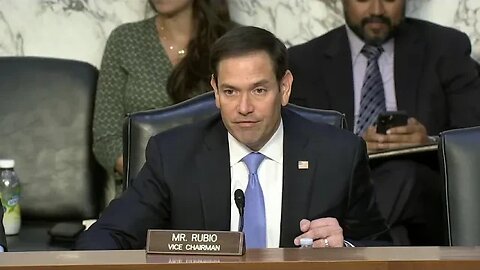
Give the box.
[289,19,480,135]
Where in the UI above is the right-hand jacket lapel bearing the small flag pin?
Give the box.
[280,112,316,247]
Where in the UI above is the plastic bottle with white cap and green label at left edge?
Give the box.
[0,159,22,235]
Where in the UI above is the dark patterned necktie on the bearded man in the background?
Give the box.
[355,45,385,136]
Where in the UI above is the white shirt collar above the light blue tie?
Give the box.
[228,119,283,167]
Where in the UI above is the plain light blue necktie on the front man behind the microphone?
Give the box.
[242,152,267,248]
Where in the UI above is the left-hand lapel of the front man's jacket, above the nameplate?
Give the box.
[192,117,231,231]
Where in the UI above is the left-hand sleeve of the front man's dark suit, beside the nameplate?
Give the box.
[75,137,170,249]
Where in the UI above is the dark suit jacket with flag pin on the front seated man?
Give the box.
[76,109,389,249]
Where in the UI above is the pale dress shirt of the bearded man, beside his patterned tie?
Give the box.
[345,26,397,130]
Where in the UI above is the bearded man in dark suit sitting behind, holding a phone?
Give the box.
[289,0,480,244]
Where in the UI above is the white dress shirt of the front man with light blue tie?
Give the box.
[228,121,283,248]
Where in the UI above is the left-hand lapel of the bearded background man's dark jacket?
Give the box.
[323,27,354,130]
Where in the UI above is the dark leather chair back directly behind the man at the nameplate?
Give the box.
[123,92,346,188]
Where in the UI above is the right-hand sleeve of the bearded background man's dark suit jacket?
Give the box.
[438,32,480,128]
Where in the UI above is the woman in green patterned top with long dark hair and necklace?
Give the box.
[93,0,233,198]
